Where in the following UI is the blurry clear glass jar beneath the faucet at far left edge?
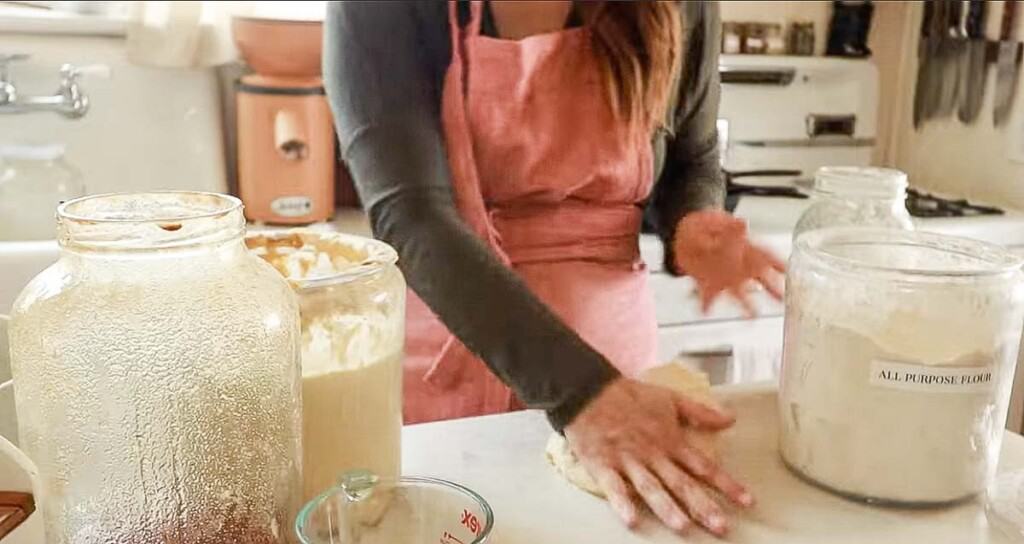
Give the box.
[0,144,85,240]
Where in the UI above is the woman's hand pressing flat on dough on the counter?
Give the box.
[565,378,754,536]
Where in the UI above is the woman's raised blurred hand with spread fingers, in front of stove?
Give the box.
[674,210,785,318]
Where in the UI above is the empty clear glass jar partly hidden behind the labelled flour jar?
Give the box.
[793,166,913,240]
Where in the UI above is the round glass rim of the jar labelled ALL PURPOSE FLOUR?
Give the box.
[797,226,1024,279]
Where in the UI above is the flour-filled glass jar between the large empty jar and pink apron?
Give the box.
[247,229,406,500]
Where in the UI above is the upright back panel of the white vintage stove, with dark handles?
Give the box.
[718,55,879,185]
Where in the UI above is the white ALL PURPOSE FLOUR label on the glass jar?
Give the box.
[870,361,994,393]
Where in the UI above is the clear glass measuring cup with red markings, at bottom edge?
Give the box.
[295,470,494,544]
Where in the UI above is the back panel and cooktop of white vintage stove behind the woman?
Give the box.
[708,55,1024,250]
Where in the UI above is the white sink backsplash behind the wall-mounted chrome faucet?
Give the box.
[0,20,225,193]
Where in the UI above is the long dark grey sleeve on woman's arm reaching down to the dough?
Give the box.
[324,2,618,430]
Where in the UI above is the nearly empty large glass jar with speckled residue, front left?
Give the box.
[10,193,301,544]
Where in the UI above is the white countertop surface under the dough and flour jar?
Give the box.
[402,384,1024,544]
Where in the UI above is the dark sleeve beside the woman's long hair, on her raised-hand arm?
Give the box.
[651,2,725,275]
